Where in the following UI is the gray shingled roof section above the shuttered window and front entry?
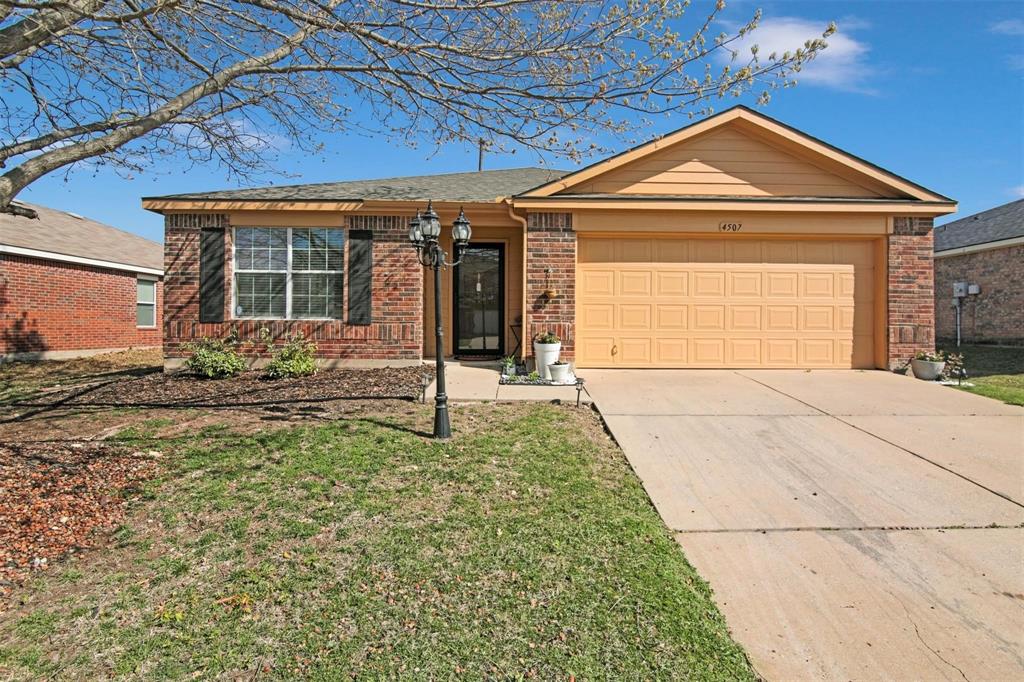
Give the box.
[146,168,567,202]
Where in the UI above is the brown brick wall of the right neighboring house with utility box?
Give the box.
[935,245,1024,344]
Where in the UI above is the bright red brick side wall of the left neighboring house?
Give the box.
[0,255,163,353]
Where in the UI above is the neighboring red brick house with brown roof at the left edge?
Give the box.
[0,203,164,361]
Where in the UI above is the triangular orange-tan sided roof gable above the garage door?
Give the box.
[520,106,950,202]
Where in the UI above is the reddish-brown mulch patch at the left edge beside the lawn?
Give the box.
[0,442,160,609]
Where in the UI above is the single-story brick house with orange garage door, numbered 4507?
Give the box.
[142,106,956,368]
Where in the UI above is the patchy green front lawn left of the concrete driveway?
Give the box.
[0,403,754,680]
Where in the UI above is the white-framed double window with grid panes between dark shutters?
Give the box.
[234,227,345,319]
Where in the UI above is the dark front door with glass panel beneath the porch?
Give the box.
[453,244,505,357]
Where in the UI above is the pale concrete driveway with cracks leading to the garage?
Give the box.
[581,370,1024,680]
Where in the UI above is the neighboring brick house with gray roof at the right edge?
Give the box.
[934,199,1024,345]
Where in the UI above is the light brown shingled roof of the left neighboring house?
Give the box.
[0,202,164,270]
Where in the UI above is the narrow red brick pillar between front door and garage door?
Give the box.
[524,213,577,359]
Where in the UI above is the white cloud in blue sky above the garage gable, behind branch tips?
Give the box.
[730,16,876,94]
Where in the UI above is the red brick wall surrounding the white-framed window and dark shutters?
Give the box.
[164,214,423,360]
